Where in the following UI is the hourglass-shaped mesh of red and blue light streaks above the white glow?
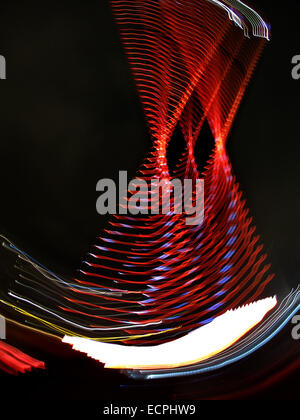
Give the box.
[2,0,273,372]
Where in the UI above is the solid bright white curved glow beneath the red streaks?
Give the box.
[63,297,277,369]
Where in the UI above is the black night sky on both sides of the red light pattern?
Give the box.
[0,0,300,289]
